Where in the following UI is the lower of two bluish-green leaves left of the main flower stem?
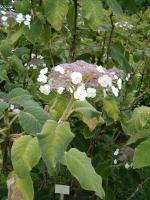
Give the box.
[19,104,50,135]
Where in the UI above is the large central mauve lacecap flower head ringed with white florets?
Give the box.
[37,61,122,101]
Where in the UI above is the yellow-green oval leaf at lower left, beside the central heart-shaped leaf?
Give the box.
[11,135,41,178]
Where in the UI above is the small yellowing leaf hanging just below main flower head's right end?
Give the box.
[103,97,120,121]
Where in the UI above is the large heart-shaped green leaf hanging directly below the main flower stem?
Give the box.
[38,120,74,174]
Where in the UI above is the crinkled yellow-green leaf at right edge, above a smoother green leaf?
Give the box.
[121,106,150,144]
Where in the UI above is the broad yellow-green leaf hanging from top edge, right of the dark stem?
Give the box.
[81,0,103,30]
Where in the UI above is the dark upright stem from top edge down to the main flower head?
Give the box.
[68,0,78,63]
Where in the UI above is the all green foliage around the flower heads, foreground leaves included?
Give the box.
[0,0,150,200]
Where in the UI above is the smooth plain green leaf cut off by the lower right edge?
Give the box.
[133,139,150,168]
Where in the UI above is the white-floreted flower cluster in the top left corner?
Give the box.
[0,11,31,28]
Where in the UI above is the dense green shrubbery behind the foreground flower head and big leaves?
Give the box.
[0,0,150,200]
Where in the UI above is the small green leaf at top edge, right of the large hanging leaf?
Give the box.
[107,0,123,15]
